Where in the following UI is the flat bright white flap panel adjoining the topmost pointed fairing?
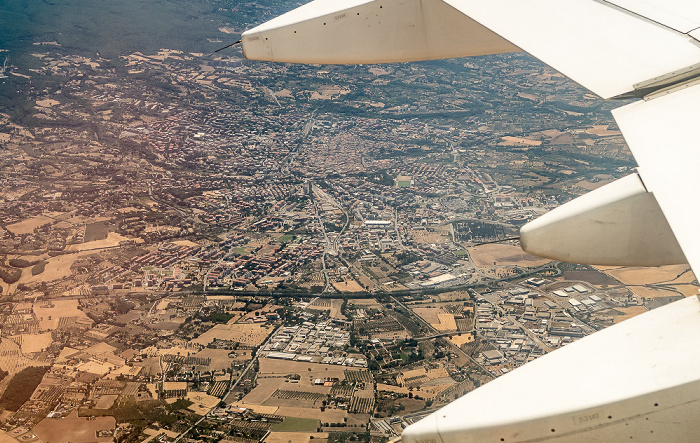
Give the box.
[445,0,700,98]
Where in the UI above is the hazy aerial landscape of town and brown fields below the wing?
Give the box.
[0,0,698,443]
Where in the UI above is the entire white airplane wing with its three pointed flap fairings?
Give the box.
[242,0,700,443]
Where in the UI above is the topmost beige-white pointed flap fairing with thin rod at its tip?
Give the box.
[241,0,519,64]
